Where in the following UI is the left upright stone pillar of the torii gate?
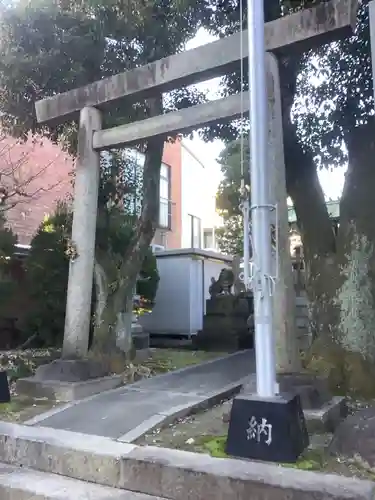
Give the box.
[62,107,102,359]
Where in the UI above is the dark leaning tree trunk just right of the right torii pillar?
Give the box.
[284,114,338,340]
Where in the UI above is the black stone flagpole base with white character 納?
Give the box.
[226,394,309,463]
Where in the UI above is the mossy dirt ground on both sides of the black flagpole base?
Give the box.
[136,401,375,480]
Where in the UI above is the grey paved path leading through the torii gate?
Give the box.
[26,351,255,442]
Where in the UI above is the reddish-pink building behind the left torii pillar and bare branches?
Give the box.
[0,137,182,248]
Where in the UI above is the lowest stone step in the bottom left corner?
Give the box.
[0,463,166,500]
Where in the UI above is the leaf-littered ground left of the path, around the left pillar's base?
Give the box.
[0,349,225,423]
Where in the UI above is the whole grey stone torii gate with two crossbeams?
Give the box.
[35,0,358,364]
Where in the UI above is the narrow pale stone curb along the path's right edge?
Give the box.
[117,377,248,443]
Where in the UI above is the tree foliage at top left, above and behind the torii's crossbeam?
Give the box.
[0,0,207,148]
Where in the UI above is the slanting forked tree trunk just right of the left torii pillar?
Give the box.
[91,98,164,371]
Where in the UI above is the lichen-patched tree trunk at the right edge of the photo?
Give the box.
[337,119,375,363]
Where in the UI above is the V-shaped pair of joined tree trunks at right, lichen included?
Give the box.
[290,121,375,397]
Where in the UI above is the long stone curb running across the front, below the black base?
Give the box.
[0,422,375,500]
